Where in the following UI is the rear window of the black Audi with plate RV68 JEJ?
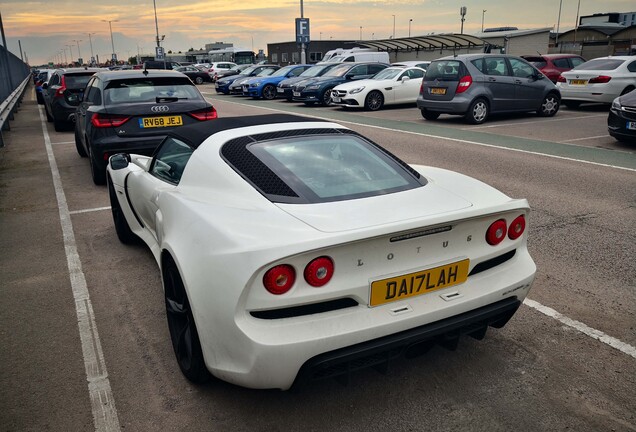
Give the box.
[104,77,201,105]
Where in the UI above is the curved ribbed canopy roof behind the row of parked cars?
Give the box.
[359,34,486,51]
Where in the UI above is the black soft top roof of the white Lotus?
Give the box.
[168,114,324,148]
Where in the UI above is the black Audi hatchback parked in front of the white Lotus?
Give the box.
[75,69,217,184]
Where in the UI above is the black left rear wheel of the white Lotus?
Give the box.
[161,255,210,383]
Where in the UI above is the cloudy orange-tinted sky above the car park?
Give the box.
[0,0,636,65]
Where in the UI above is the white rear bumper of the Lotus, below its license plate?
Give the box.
[195,248,536,390]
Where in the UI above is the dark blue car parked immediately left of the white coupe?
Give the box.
[292,62,389,106]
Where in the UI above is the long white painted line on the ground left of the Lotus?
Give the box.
[38,106,121,432]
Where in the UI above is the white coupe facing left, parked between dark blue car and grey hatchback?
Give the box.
[331,67,426,111]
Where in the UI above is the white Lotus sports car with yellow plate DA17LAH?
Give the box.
[107,114,536,389]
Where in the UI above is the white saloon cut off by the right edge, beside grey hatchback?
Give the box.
[556,56,636,108]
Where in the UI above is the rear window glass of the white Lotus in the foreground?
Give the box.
[248,134,422,203]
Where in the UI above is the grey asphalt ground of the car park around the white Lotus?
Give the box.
[0,85,636,432]
